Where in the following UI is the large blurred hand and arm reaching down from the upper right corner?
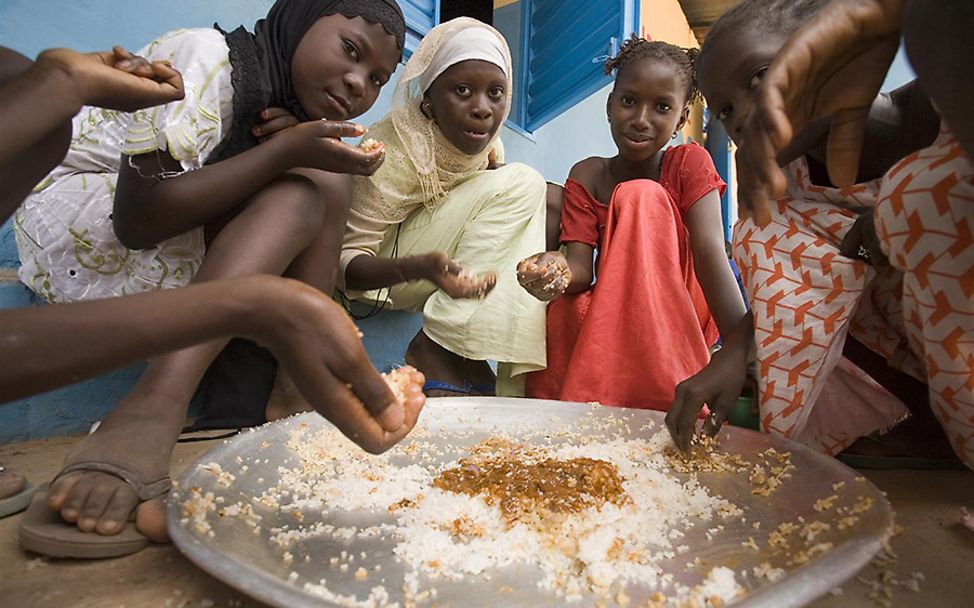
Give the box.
[738,0,974,223]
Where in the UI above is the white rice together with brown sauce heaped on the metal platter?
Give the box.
[246,416,750,606]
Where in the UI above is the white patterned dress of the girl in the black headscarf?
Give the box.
[14,28,233,303]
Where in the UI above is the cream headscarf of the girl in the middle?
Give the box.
[352,17,514,222]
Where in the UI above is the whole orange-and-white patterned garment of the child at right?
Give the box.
[734,121,974,466]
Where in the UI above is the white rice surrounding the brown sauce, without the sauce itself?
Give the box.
[250,420,742,606]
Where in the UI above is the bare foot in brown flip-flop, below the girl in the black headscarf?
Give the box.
[48,393,186,542]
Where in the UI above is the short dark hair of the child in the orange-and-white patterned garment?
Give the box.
[700,0,829,61]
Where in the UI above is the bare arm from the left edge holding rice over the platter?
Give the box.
[0,276,424,452]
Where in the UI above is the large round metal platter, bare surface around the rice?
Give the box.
[167,397,892,608]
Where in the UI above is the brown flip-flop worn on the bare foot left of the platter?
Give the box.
[19,462,172,559]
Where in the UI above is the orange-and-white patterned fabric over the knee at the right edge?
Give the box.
[875,122,974,468]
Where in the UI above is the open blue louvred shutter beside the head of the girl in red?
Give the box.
[517,0,638,131]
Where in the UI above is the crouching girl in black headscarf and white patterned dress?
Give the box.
[15,0,405,556]
